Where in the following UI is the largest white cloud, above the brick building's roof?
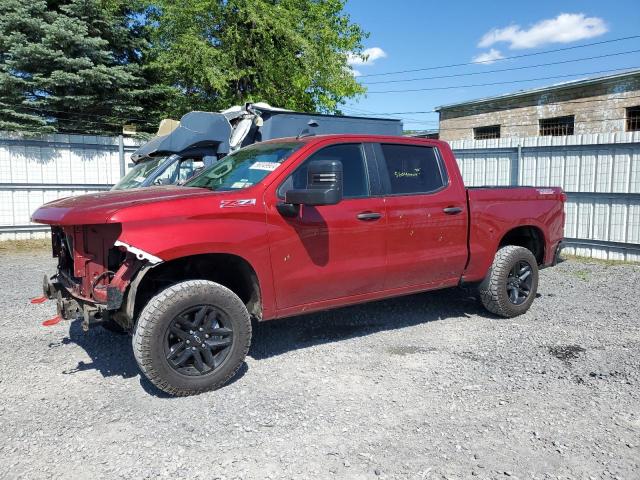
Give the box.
[478,13,608,50]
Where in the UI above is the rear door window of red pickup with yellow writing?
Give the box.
[381,144,447,195]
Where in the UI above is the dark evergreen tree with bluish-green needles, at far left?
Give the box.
[0,0,155,133]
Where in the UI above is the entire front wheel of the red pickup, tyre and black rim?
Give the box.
[133,280,251,396]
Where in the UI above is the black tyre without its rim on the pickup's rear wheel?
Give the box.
[478,245,538,318]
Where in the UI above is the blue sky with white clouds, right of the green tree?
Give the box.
[344,0,640,129]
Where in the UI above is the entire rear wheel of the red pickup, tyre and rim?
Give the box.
[479,245,538,318]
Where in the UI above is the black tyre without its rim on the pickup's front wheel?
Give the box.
[133,280,251,396]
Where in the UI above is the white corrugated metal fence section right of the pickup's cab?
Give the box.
[450,132,640,261]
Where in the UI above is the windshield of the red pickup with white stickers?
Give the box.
[184,142,302,190]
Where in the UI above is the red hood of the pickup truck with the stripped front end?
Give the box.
[31,186,212,225]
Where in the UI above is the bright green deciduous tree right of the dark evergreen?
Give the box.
[144,0,366,116]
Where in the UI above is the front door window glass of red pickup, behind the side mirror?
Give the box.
[278,143,369,198]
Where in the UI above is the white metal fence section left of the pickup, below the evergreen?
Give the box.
[0,132,137,240]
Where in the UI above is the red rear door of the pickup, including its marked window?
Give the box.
[375,143,468,289]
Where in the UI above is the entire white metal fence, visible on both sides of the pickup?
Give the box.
[0,132,640,261]
